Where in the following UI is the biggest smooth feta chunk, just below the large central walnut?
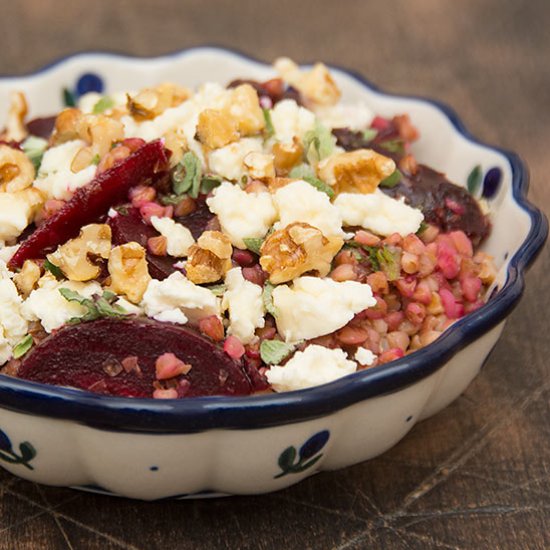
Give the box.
[273,277,376,342]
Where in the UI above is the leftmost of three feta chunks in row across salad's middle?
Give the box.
[206,181,277,249]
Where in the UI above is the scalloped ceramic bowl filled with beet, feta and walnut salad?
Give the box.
[0,48,546,498]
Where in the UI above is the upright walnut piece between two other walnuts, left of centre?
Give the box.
[108,242,151,304]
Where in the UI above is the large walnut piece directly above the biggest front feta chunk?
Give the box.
[260,222,344,284]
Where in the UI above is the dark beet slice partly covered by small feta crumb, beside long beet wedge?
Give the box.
[107,206,181,281]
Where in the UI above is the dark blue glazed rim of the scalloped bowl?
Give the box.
[0,46,548,434]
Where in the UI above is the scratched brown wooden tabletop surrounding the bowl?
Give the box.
[0,0,550,550]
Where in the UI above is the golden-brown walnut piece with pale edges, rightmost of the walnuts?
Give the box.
[317,149,395,193]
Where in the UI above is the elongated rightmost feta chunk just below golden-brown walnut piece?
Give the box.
[334,189,424,236]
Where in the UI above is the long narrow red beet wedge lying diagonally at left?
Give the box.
[9,140,168,269]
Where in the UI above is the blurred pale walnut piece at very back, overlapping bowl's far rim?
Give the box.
[274,57,342,105]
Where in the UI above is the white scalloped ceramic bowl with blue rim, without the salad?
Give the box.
[0,48,548,500]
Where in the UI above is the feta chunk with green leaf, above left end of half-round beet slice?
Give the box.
[21,275,102,332]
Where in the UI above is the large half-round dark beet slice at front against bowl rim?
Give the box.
[18,319,254,397]
